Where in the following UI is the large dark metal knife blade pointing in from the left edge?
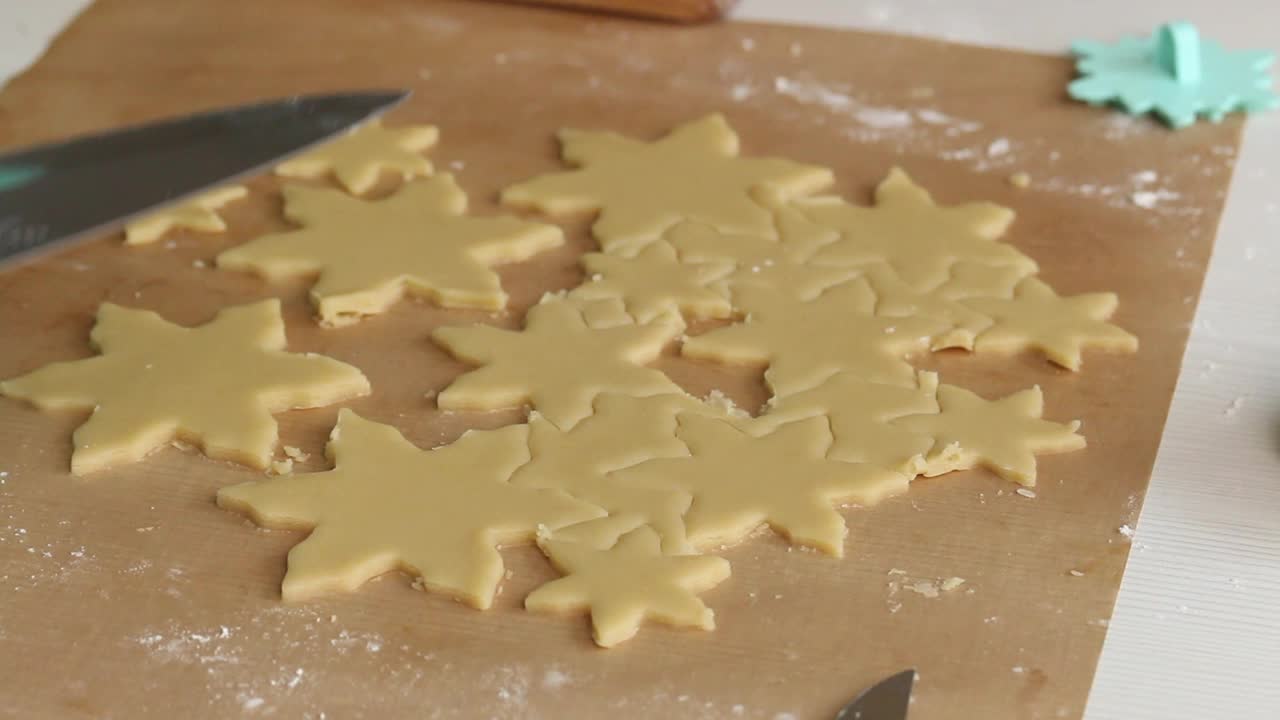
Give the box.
[0,91,408,263]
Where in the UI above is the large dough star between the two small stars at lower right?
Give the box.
[613,414,908,557]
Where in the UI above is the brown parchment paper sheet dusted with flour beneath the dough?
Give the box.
[0,0,1239,720]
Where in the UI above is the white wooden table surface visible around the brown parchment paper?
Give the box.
[0,0,1280,720]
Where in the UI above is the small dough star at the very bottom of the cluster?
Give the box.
[525,527,730,647]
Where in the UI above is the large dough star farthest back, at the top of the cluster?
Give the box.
[502,114,833,255]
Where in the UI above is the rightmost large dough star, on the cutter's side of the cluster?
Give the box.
[796,168,1037,291]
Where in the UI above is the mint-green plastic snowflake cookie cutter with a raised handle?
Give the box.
[1066,22,1280,128]
